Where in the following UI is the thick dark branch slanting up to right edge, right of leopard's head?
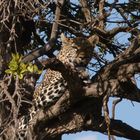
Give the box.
[92,37,140,81]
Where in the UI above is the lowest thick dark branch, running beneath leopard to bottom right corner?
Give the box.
[36,97,140,140]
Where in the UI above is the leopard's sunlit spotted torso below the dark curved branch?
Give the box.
[33,71,67,109]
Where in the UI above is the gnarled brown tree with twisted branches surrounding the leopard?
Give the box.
[0,0,140,140]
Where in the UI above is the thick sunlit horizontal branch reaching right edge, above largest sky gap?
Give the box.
[85,80,140,103]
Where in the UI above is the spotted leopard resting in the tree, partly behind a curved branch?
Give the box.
[18,33,96,140]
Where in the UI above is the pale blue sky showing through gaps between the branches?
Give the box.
[62,0,140,140]
